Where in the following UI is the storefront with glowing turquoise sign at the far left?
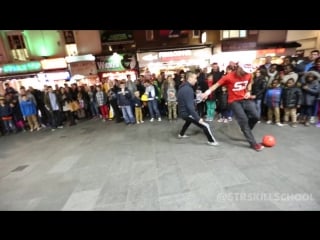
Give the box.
[0,61,42,94]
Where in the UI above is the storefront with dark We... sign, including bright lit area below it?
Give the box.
[96,53,138,81]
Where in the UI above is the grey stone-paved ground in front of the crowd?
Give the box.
[0,117,320,210]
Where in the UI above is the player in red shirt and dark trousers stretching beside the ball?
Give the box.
[202,63,264,151]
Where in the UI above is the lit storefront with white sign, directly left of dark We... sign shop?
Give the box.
[65,54,99,86]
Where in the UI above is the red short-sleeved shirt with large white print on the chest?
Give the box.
[217,72,252,103]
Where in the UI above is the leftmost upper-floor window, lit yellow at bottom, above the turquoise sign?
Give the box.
[7,34,29,61]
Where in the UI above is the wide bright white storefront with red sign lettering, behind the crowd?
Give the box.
[137,47,212,75]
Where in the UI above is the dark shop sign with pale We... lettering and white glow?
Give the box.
[96,53,137,72]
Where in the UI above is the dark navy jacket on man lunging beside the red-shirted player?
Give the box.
[178,81,200,122]
